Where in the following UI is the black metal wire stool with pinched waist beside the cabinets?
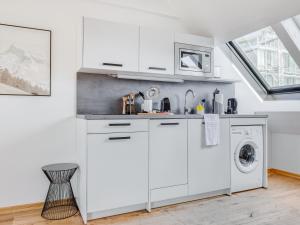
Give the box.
[42,163,78,220]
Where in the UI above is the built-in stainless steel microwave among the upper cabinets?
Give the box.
[175,43,214,77]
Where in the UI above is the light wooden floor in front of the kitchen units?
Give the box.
[0,174,300,225]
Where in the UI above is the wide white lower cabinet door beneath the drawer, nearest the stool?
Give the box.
[87,132,148,213]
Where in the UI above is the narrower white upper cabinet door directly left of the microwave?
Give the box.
[140,27,174,75]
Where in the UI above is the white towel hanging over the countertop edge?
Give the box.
[204,114,220,146]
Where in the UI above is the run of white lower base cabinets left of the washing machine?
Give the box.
[77,118,262,223]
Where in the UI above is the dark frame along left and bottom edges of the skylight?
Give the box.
[227,41,300,95]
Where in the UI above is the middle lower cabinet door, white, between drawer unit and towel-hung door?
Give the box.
[149,119,187,189]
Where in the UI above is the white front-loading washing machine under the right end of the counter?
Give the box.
[231,126,264,192]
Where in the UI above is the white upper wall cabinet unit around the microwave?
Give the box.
[78,17,234,83]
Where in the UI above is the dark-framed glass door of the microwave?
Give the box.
[180,50,202,72]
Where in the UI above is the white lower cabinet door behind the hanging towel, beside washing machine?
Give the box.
[188,119,230,195]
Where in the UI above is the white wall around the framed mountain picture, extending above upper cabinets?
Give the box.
[0,0,190,207]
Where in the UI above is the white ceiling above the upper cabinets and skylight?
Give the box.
[97,0,300,41]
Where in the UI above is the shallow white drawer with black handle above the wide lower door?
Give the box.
[88,120,148,134]
